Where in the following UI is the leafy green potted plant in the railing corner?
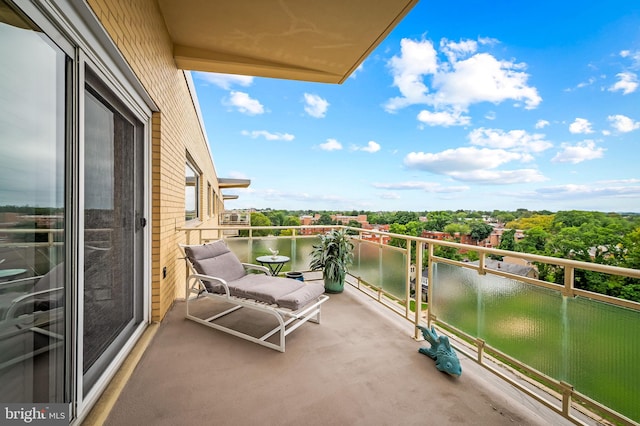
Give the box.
[309,229,353,293]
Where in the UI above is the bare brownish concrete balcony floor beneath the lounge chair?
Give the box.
[96,286,596,426]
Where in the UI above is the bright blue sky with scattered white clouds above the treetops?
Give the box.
[193,0,640,212]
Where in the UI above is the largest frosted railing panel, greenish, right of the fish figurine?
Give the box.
[430,263,640,419]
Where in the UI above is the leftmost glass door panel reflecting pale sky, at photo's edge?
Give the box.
[0,0,69,403]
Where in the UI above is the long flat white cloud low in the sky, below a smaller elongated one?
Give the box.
[404,147,545,184]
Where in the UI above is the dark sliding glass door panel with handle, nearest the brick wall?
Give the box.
[83,71,144,395]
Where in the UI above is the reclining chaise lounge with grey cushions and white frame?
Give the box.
[180,240,329,352]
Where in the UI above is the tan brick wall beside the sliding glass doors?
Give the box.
[88,0,222,321]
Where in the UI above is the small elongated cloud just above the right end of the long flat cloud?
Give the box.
[469,127,553,153]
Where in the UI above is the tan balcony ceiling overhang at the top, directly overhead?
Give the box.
[153,0,418,83]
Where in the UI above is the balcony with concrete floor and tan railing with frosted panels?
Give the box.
[94,227,640,425]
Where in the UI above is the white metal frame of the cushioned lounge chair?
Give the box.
[179,244,329,352]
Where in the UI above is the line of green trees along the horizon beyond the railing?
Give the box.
[246,209,640,302]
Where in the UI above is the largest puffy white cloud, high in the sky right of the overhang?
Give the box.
[385,39,542,121]
